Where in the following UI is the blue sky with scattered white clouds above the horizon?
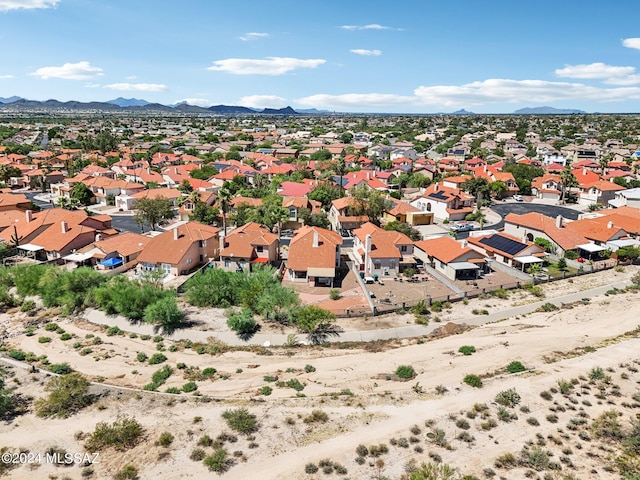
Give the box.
[0,0,640,113]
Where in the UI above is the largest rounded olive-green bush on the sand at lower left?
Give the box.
[35,373,92,418]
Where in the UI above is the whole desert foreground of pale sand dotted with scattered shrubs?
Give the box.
[0,266,640,480]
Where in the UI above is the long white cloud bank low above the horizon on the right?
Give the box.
[296,78,640,111]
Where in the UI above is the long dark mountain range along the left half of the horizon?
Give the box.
[0,96,300,115]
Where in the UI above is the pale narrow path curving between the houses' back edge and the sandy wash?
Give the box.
[84,280,631,346]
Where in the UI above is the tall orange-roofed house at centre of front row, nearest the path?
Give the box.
[286,226,342,287]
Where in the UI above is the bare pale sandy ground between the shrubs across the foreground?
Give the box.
[0,268,640,479]
